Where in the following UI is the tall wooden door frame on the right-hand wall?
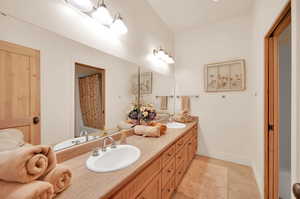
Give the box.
[264,1,291,199]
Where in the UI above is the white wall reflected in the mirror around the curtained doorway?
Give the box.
[0,16,137,144]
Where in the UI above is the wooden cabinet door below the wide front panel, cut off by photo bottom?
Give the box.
[137,174,161,199]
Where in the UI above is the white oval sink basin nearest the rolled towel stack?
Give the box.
[86,145,141,172]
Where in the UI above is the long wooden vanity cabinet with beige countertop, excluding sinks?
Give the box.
[57,122,198,199]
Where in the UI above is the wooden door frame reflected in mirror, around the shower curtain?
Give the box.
[74,62,106,130]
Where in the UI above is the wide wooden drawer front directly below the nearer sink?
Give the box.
[112,158,161,199]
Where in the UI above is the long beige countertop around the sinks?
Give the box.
[57,122,196,199]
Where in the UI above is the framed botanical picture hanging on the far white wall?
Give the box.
[204,59,246,92]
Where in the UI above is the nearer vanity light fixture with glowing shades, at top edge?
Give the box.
[64,0,128,35]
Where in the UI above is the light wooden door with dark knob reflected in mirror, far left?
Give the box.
[0,41,40,144]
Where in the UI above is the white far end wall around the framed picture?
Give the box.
[175,16,257,166]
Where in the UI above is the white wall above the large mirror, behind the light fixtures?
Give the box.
[0,0,173,71]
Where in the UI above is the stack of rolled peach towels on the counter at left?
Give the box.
[0,145,72,199]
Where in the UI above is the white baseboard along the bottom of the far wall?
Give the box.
[197,152,252,167]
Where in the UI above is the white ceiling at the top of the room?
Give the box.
[147,0,255,32]
